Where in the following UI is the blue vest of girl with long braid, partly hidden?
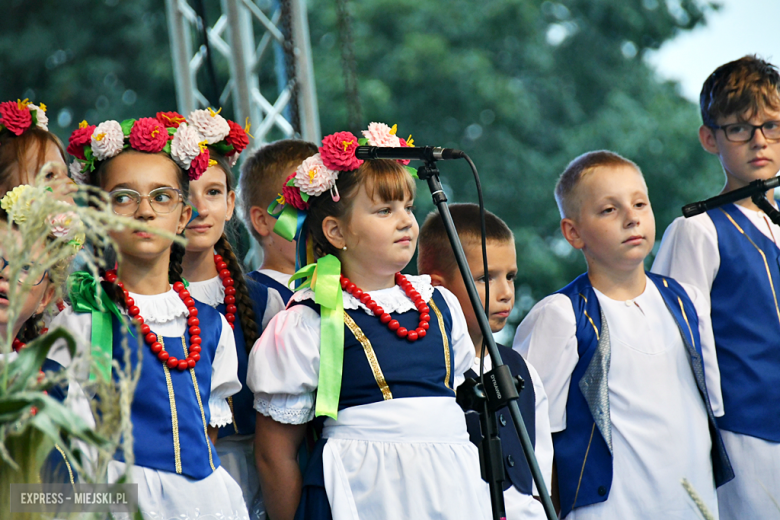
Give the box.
[217,279,268,438]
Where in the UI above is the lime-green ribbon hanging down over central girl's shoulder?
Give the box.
[289,255,344,420]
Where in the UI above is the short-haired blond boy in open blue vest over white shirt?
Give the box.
[513,151,733,520]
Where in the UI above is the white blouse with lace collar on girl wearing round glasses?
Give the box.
[49,289,241,427]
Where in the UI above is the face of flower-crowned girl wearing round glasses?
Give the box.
[102,152,192,260]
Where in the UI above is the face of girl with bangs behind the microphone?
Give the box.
[326,185,420,276]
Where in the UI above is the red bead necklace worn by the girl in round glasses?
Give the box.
[106,270,201,371]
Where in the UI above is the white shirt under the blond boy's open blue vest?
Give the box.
[513,278,722,520]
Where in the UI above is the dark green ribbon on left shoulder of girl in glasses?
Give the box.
[68,271,123,381]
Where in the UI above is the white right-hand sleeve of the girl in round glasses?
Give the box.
[209,314,241,428]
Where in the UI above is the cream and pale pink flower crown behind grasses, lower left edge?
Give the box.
[0,184,86,254]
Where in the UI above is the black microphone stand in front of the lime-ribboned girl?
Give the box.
[417,158,557,520]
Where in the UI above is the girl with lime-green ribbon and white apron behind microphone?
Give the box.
[247,123,490,520]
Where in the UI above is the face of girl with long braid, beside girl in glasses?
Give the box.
[185,162,236,252]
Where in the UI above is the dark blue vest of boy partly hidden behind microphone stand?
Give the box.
[464,345,536,495]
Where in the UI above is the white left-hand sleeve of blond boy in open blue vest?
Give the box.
[512,294,579,432]
